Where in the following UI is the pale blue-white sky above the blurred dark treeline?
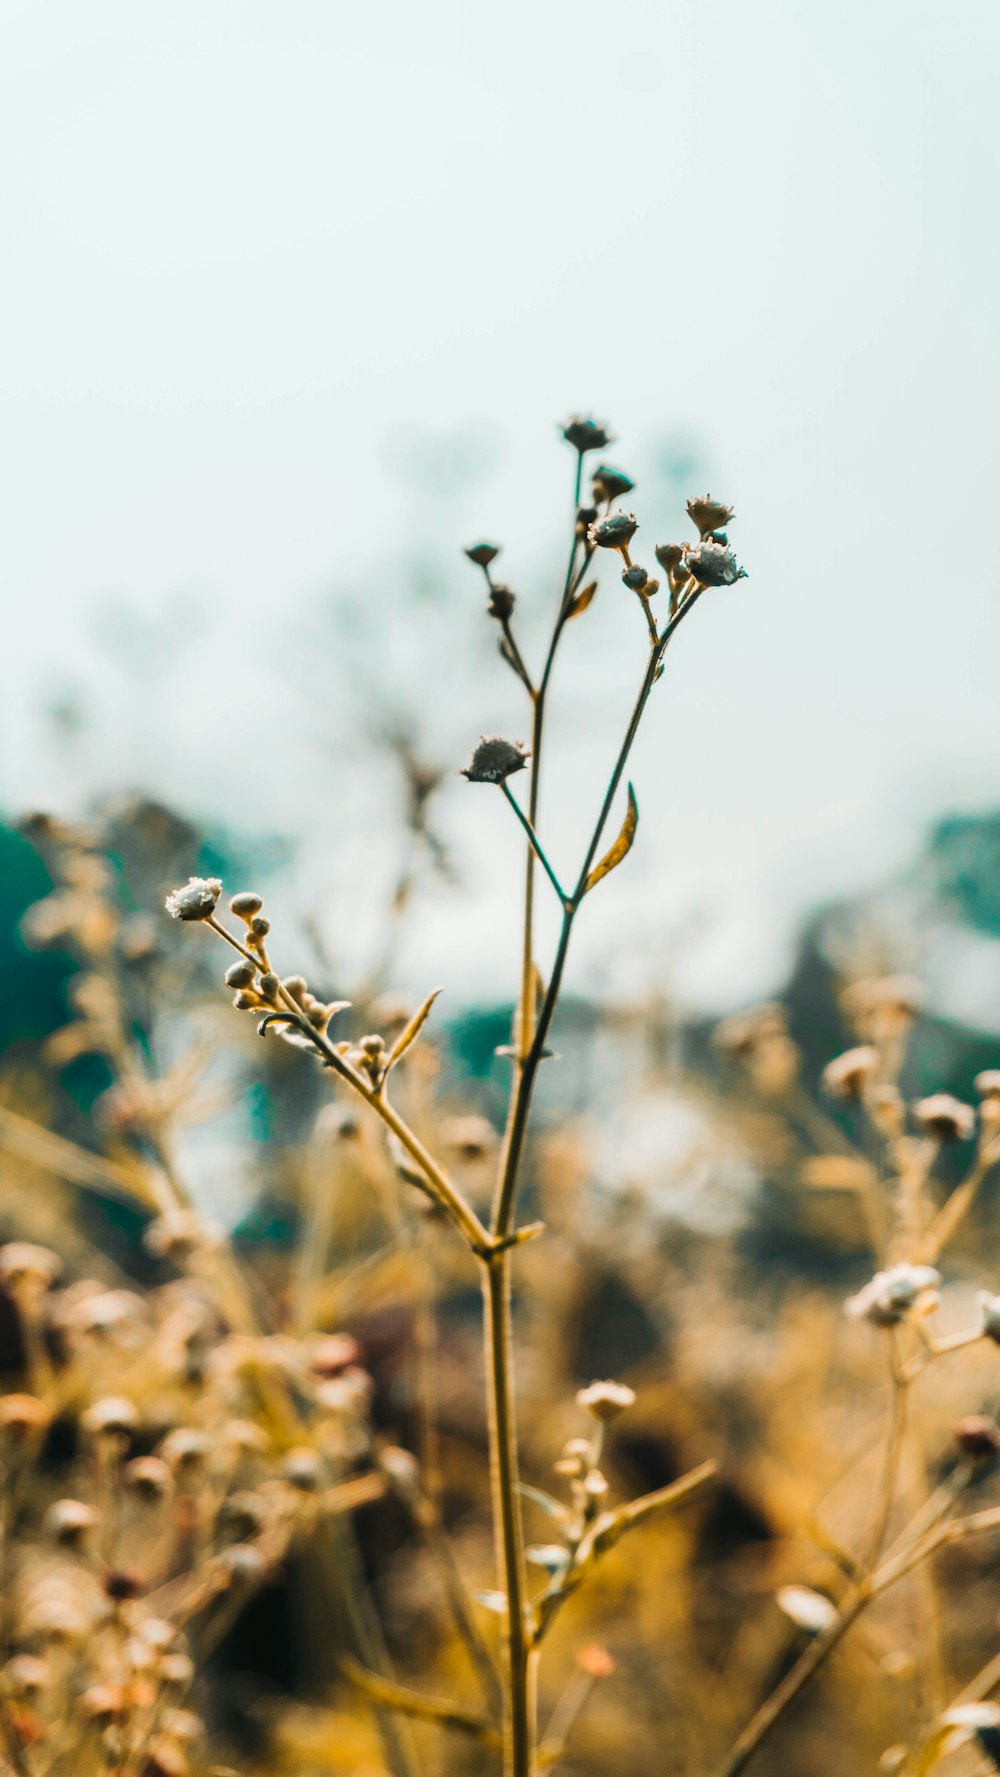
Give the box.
[0,0,1000,999]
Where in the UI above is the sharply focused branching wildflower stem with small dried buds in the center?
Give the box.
[167,418,744,1777]
